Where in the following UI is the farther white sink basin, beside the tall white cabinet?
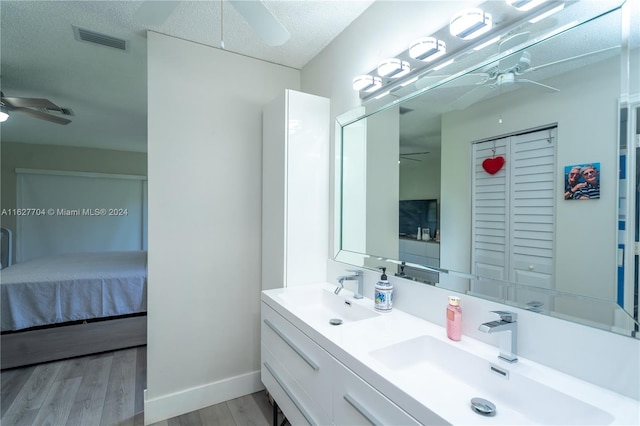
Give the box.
[277,288,380,325]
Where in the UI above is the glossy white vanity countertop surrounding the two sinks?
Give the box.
[262,283,640,425]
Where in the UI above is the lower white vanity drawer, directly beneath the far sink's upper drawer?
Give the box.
[261,344,331,426]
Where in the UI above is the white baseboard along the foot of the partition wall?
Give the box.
[144,370,264,425]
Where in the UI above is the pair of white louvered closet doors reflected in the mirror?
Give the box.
[471,128,556,305]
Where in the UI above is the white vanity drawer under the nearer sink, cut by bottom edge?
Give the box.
[333,361,420,426]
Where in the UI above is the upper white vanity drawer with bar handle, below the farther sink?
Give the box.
[261,303,332,413]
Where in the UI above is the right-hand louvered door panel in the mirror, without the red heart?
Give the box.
[509,129,556,288]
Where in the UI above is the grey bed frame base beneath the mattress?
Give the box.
[0,314,147,370]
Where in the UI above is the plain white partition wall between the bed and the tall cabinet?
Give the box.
[145,33,300,423]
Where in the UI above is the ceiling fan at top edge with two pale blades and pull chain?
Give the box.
[136,0,291,49]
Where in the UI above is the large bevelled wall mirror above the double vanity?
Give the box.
[336,1,640,337]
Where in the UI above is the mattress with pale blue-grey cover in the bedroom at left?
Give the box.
[0,251,147,331]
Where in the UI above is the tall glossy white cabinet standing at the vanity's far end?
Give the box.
[262,90,330,289]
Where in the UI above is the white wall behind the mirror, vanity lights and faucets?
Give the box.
[302,1,640,399]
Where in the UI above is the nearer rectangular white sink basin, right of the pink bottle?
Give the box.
[370,336,614,425]
